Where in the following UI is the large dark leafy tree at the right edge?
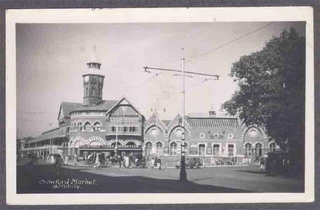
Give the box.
[222,28,306,159]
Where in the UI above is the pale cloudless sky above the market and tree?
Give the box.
[16,22,305,137]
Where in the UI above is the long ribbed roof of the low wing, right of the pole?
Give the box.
[187,117,239,128]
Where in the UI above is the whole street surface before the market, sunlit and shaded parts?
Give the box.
[17,161,303,193]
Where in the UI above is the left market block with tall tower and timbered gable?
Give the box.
[22,48,144,156]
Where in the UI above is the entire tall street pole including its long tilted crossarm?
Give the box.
[143,48,219,182]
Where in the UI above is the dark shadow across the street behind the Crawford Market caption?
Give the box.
[17,165,249,194]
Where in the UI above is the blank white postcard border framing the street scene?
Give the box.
[6,7,315,205]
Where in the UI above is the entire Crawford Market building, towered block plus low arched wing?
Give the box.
[21,49,277,165]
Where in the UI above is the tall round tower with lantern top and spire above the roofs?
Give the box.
[82,46,104,106]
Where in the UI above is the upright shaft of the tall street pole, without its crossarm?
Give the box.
[179,48,187,182]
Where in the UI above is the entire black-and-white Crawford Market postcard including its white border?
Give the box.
[7,8,314,204]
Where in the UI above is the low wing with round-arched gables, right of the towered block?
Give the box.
[144,111,278,166]
